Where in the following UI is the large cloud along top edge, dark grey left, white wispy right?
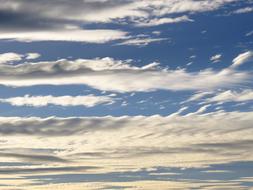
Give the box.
[0,0,236,24]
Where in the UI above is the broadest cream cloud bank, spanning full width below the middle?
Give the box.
[0,109,253,168]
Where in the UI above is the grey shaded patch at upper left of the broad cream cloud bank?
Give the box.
[0,118,127,136]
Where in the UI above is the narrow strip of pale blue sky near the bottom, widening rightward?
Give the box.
[24,162,253,187]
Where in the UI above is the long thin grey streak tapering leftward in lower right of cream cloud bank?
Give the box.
[70,140,253,160]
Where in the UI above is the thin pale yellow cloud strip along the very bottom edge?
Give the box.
[8,180,251,190]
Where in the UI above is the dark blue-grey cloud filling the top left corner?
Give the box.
[0,0,130,32]
